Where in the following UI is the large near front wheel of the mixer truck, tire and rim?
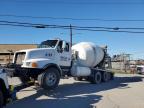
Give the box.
[39,68,60,90]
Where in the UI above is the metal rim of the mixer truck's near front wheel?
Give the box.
[46,73,57,86]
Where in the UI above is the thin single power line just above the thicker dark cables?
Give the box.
[0,14,144,22]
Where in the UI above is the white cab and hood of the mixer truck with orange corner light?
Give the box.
[13,40,71,69]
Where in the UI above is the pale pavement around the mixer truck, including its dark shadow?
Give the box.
[6,74,144,108]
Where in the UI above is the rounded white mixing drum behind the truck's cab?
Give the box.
[72,42,104,67]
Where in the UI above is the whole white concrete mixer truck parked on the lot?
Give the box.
[5,39,113,90]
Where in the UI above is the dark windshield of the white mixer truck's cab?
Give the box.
[38,40,58,48]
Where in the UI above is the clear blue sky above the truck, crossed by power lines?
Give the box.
[0,0,144,59]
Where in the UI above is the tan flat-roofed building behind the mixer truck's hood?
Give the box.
[0,44,37,65]
